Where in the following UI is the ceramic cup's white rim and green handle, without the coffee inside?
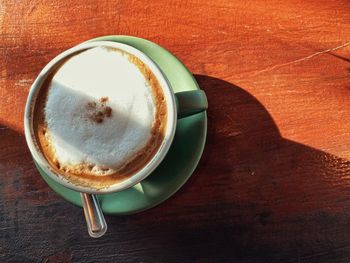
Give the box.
[24,41,208,194]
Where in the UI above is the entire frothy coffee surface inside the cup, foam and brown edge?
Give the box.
[33,47,167,189]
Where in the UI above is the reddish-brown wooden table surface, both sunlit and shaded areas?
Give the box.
[0,0,350,262]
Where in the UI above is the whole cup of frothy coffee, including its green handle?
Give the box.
[24,41,208,194]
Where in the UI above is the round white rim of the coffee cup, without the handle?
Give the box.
[24,41,177,194]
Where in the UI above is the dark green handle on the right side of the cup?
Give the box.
[175,90,208,119]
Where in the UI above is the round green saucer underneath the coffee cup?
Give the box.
[38,36,207,214]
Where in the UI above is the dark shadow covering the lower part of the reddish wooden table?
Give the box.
[0,75,350,262]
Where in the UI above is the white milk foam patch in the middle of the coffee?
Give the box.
[45,47,155,174]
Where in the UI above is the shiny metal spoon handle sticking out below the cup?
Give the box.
[80,193,107,238]
